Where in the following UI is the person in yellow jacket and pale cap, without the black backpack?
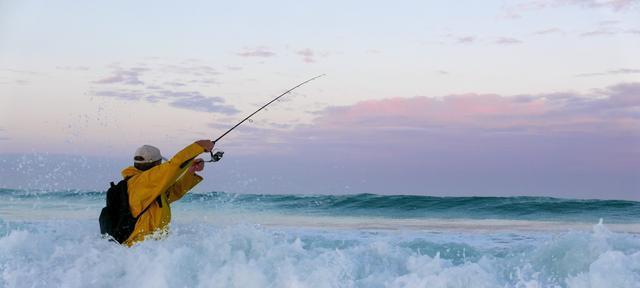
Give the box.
[117,140,214,246]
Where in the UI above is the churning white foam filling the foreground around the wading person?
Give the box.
[0,220,640,287]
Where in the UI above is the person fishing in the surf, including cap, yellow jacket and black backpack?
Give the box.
[100,140,214,246]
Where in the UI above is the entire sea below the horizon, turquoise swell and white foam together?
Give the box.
[0,189,640,288]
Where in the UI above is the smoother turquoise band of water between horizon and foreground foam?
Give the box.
[0,189,640,223]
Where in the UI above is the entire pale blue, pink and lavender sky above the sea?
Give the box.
[0,0,640,200]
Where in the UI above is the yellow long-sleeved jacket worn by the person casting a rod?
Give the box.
[122,143,204,246]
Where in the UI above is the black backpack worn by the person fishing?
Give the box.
[100,177,153,244]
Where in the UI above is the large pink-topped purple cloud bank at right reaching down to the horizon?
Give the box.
[206,83,640,199]
